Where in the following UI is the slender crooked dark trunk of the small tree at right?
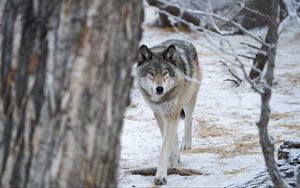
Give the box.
[257,0,289,188]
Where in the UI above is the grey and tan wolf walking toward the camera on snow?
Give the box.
[136,40,201,185]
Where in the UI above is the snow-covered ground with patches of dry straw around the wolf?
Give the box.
[118,7,300,187]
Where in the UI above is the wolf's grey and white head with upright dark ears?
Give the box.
[137,45,180,98]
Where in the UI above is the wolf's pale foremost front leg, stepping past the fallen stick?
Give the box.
[154,118,178,185]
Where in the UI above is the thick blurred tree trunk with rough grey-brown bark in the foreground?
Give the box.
[0,0,143,187]
